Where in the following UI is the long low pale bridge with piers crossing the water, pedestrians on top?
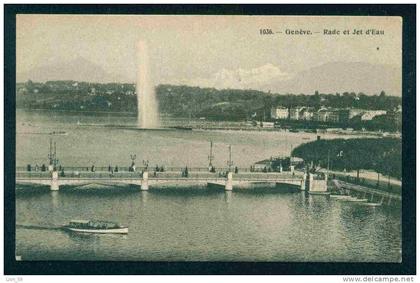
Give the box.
[16,168,327,192]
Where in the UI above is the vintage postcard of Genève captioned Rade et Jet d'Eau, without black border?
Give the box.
[4,3,414,276]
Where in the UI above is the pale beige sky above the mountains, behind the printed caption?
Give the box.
[16,15,402,91]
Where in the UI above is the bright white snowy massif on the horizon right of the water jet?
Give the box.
[167,64,292,89]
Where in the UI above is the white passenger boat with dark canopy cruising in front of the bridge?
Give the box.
[63,220,128,234]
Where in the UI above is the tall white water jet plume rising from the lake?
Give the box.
[136,41,160,129]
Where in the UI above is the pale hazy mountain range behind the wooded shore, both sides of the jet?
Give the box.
[16,57,402,96]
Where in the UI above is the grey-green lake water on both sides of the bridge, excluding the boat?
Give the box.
[16,110,401,262]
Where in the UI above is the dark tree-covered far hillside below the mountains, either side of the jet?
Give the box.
[16,81,401,123]
